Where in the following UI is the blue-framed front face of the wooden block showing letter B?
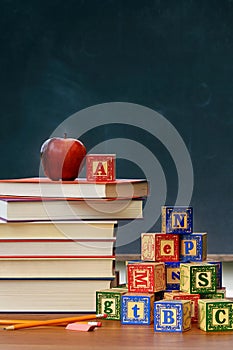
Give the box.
[154,300,189,332]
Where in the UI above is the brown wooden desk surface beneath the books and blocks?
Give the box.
[0,314,233,350]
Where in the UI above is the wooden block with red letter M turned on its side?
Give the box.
[127,262,166,293]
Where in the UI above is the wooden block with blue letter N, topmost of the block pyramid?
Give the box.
[162,206,193,234]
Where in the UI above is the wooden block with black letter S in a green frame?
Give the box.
[180,263,216,294]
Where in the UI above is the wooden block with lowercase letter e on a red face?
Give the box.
[141,233,180,261]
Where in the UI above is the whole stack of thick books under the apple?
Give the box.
[0,178,148,312]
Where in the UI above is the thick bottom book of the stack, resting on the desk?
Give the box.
[0,278,112,312]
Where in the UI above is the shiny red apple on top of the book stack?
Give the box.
[41,134,86,181]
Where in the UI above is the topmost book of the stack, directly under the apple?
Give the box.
[0,177,149,198]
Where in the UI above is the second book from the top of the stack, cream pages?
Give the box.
[0,196,143,221]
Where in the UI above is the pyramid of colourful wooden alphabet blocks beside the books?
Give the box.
[97,207,233,332]
